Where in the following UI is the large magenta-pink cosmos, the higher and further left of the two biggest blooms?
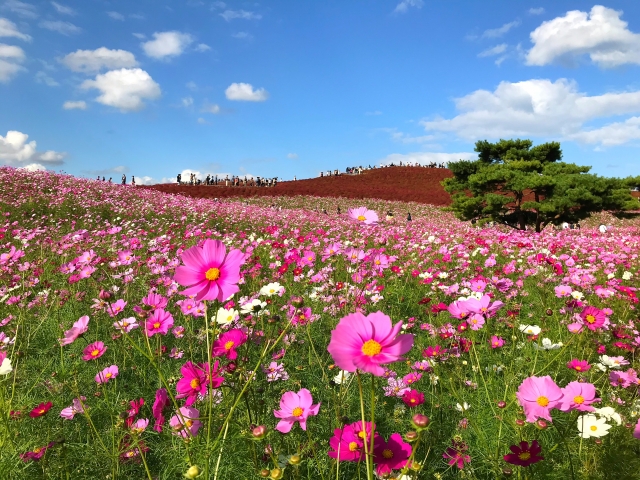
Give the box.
[173,240,244,301]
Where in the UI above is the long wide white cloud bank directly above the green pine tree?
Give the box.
[421,79,640,145]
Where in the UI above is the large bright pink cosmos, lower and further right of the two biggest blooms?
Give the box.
[327,312,413,377]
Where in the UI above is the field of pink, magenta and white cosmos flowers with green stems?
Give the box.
[0,168,640,480]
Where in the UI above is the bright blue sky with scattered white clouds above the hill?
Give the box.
[0,0,640,183]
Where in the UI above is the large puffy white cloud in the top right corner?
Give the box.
[527,5,640,68]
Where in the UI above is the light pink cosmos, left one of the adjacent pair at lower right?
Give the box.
[516,375,563,423]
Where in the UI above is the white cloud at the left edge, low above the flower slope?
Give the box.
[0,130,67,169]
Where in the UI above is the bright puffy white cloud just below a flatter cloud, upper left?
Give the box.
[80,68,161,112]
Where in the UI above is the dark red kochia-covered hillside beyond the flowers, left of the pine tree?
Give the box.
[148,167,452,205]
